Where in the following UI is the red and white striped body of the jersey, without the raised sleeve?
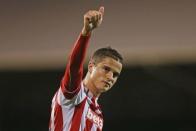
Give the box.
[50,84,103,131]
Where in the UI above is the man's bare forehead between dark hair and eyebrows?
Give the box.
[97,57,122,73]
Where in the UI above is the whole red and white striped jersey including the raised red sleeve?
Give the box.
[49,35,103,131]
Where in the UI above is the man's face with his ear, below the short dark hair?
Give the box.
[89,57,122,93]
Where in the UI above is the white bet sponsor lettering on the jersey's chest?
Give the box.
[86,108,103,130]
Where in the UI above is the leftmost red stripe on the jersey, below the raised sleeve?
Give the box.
[54,102,63,131]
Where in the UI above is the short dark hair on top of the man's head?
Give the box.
[91,46,123,64]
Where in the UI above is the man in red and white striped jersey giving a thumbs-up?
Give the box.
[49,7,122,131]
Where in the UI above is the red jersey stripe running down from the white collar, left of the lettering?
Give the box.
[70,97,87,131]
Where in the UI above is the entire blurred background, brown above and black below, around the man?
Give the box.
[0,0,196,131]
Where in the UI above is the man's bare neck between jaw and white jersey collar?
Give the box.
[83,73,101,97]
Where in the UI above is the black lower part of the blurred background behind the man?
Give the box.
[0,64,196,131]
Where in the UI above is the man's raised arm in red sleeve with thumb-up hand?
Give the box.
[61,7,104,98]
